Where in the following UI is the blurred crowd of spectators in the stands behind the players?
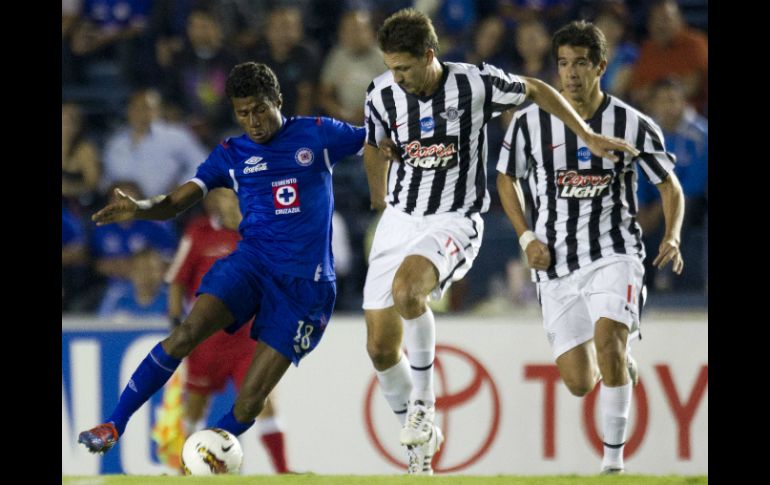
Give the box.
[61,0,708,316]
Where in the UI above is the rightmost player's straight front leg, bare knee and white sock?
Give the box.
[594,318,632,473]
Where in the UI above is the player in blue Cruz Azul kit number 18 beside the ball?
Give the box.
[78,62,365,453]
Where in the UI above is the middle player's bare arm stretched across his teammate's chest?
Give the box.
[522,76,639,162]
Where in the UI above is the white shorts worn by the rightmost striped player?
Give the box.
[537,255,645,359]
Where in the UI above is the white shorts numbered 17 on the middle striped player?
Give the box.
[363,206,484,310]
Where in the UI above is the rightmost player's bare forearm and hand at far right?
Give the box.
[652,172,684,274]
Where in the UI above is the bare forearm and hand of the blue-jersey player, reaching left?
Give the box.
[91,182,203,226]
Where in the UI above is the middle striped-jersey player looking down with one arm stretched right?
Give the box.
[363,9,636,474]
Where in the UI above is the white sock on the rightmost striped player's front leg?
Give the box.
[599,382,632,468]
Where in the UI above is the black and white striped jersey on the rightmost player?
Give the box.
[497,94,676,281]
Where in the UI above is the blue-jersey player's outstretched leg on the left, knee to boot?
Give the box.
[78,294,234,453]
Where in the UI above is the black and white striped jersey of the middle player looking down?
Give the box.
[365,62,526,216]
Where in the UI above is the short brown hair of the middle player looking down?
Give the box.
[377,8,439,57]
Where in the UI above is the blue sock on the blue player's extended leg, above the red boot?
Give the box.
[107,343,181,435]
